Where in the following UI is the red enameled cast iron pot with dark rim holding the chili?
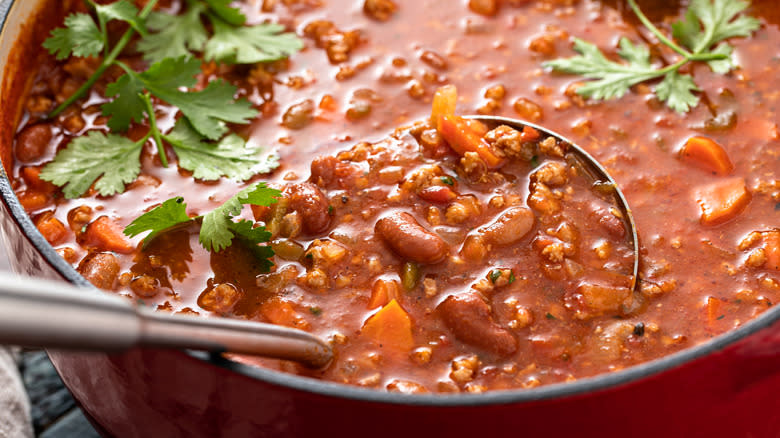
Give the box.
[0,0,780,438]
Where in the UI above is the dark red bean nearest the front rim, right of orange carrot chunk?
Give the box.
[436,292,517,356]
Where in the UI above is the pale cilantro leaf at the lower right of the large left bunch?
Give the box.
[163,119,278,181]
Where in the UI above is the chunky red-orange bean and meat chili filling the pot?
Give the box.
[9,0,780,393]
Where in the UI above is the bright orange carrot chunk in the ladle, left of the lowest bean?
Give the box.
[360,299,414,353]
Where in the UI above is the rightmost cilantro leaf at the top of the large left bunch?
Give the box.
[204,19,303,64]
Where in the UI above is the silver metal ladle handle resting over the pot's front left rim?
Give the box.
[0,273,333,368]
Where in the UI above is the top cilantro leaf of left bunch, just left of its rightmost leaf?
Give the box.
[138,2,208,62]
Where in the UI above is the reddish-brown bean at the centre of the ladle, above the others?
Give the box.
[374,212,449,264]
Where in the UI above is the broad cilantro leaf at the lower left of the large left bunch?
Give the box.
[41,131,145,199]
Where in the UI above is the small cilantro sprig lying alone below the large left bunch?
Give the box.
[124,183,281,270]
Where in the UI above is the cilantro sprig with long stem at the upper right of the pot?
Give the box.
[544,0,761,113]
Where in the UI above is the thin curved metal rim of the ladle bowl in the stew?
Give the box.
[466,116,639,290]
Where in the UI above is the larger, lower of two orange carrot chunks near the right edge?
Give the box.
[696,177,752,225]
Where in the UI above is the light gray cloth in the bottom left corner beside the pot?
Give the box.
[0,346,33,438]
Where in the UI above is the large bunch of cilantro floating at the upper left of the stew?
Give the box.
[41,0,303,198]
